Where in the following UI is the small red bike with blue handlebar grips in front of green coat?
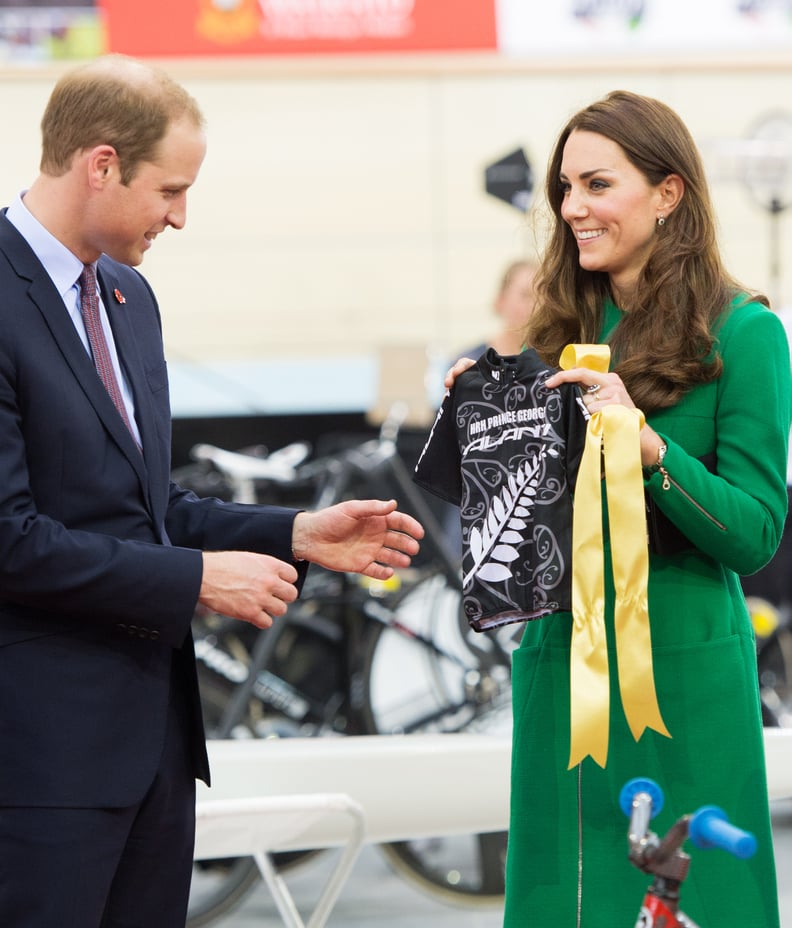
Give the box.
[619,778,756,928]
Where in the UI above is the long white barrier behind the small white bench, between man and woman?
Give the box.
[198,734,511,849]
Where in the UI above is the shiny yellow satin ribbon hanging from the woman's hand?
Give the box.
[560,345,670,768]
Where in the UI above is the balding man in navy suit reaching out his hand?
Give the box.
[0,56,423,928]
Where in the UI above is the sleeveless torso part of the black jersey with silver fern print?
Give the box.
[456,371,571,629]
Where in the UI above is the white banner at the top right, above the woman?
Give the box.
[496,0,792,60]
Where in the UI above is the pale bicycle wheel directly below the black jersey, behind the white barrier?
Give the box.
[362,574,514,905]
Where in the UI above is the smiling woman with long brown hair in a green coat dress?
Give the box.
[446,91,790,928]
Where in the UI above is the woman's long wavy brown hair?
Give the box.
[527,90,768,412]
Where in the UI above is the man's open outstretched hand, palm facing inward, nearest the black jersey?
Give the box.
[292,499,424,580]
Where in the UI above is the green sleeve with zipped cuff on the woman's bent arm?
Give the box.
[648,303,790,574]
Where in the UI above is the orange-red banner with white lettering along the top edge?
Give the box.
[100,0,496,56]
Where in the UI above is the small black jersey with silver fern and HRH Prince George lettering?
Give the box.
[414,348,588,631]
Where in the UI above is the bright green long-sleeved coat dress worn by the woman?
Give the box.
[504,299,790,928]
